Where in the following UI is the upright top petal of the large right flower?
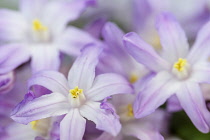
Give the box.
[156,13,189,62]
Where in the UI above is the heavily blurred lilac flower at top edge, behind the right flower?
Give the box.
[132,0,209,44]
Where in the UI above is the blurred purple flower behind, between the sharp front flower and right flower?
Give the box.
[98,22,147,83]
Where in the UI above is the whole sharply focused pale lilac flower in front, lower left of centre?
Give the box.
[11,45,132,140]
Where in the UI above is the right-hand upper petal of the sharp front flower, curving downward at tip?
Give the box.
[86,73,133,101]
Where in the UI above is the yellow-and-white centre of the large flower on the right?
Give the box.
[172,58,190,80]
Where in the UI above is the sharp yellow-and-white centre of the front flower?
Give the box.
[69,86,85,107]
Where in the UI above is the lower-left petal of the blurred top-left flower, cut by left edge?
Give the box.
[0,44,30,74]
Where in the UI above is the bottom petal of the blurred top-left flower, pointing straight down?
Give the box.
[31,45,60,73]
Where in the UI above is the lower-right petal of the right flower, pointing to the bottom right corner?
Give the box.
[176,82,210,133]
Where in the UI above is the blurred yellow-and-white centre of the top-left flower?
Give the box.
[32,19,50,43]
